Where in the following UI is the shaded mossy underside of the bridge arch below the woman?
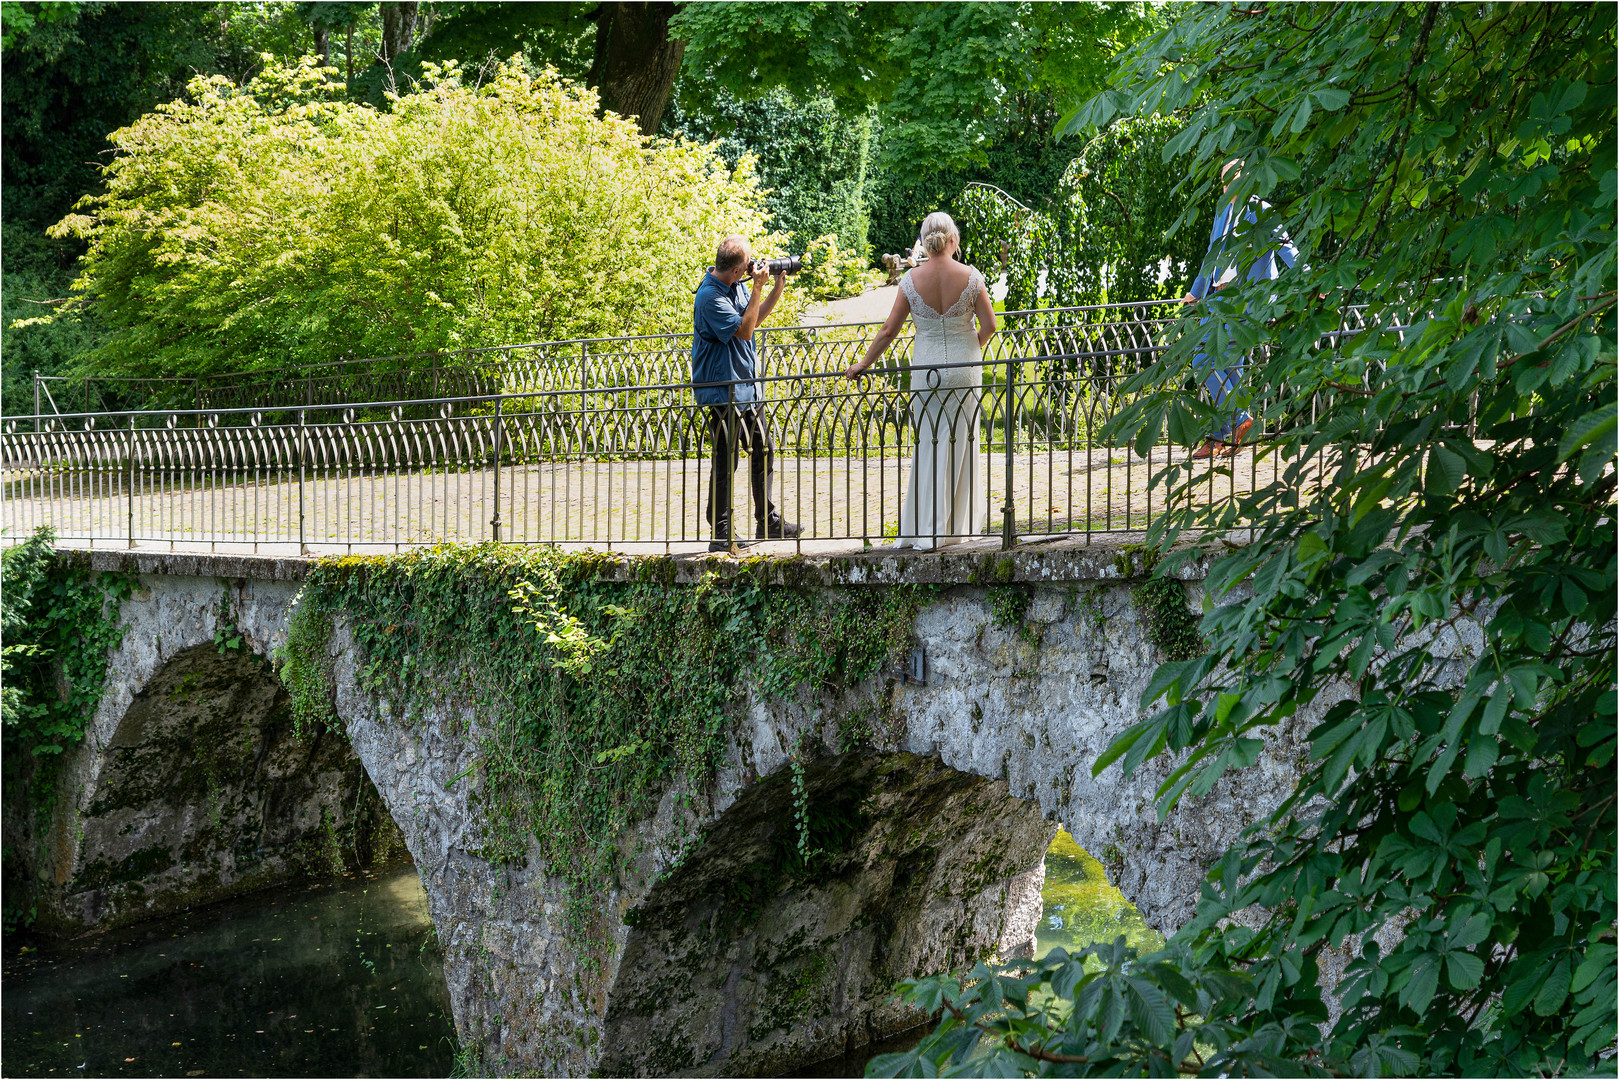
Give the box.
[597,751,1056,1075]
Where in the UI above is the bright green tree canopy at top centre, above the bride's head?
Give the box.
[672,0,1162,262]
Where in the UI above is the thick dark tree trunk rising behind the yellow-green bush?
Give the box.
[588,3,686,134]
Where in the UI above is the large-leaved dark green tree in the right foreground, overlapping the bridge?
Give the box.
[873,3,1619,1077]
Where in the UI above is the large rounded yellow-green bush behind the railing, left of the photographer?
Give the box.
[53,62,798,374]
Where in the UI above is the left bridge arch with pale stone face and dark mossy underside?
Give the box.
[6,560,403,933]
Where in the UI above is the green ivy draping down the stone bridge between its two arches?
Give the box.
[282,544,931,942]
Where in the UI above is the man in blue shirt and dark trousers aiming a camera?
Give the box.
[691,236,800,551]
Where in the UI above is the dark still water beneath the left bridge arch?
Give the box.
[0,866,455,1077]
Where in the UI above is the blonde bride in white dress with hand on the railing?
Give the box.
[843,212,996,547]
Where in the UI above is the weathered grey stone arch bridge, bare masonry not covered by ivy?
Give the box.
[22,544,1340,1075]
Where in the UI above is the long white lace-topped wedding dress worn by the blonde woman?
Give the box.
[894,270,989,549]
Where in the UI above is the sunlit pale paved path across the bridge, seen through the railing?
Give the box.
[0,449,1276,551]
